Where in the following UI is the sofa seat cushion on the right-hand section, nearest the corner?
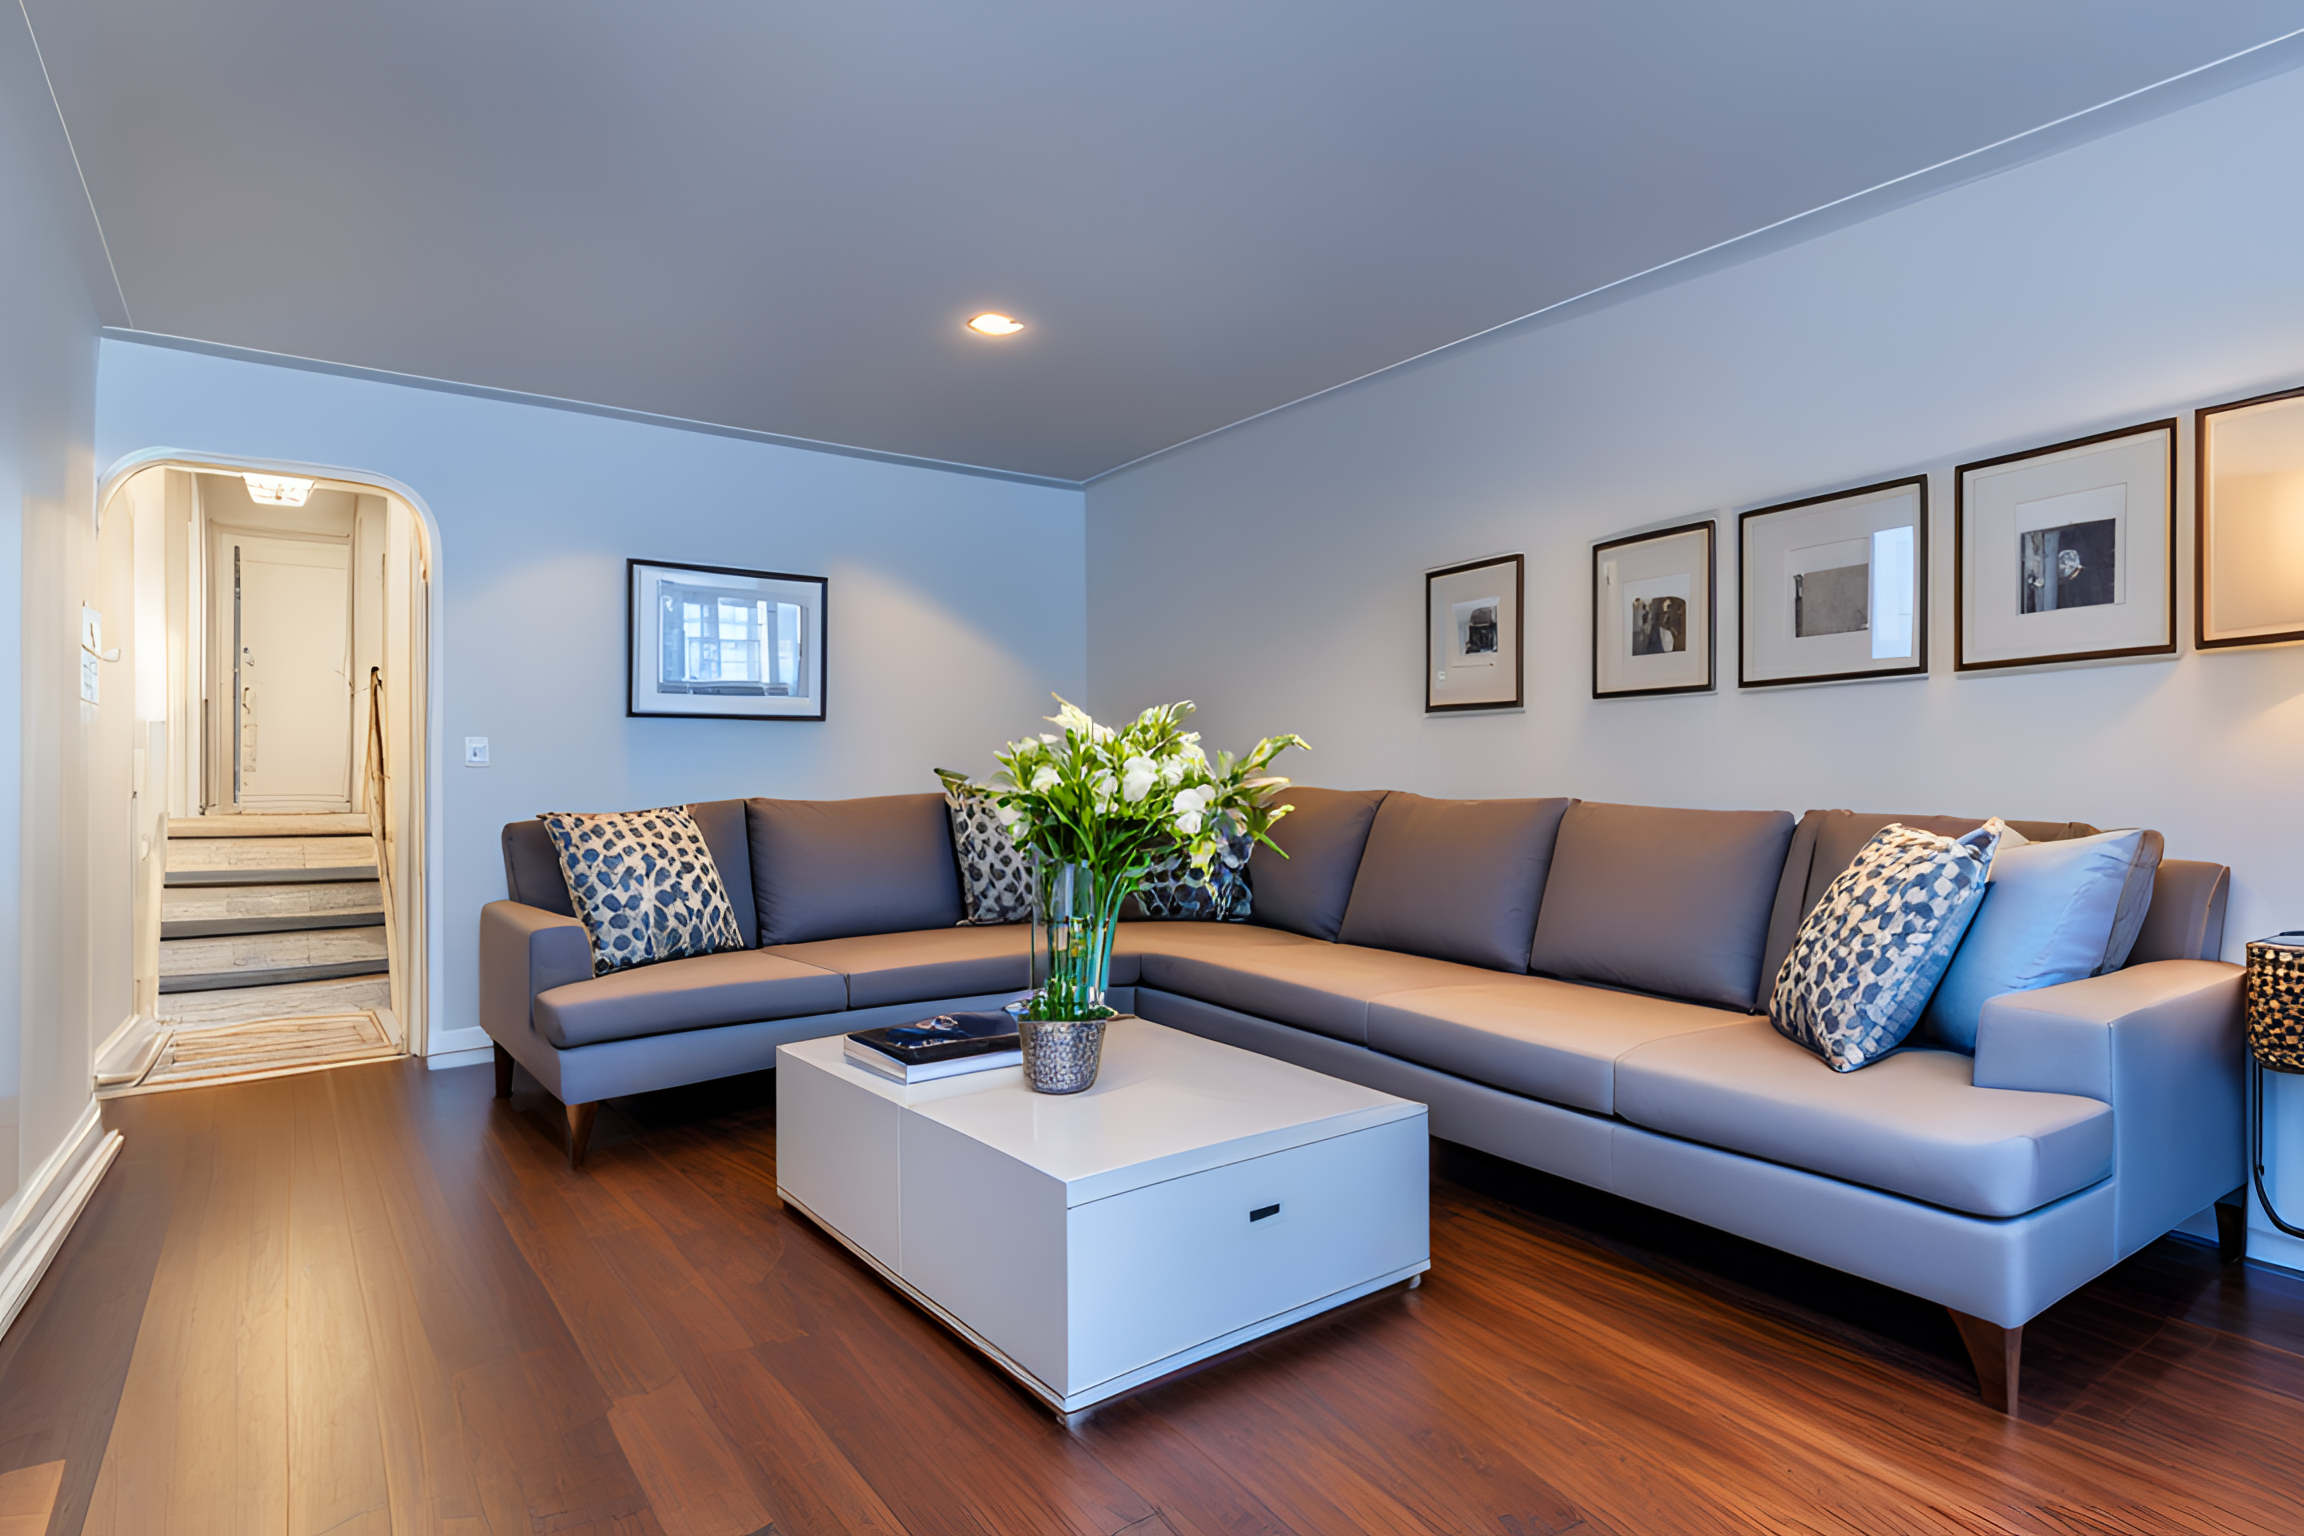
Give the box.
[1138,944,1495,1045]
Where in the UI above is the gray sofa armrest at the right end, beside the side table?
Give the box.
[1975,960,2246,1257]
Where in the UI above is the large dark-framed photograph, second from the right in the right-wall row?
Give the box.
[1951,417,2175,672]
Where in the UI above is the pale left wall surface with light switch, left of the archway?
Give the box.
[0,12,110,1214]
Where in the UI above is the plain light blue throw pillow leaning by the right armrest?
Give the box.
[1919,831,2145,1055]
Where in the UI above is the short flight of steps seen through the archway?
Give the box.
[159,813,392,1029]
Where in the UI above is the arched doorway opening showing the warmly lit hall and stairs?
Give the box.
[83,449,438,1094]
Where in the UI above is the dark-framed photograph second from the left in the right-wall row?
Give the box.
[1592,523,1719,698]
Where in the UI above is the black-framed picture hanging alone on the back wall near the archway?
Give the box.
[624,560,825,721]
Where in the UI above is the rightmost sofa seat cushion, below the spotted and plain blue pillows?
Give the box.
[1615,1020,2113,1216]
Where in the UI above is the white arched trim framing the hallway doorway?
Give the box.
[94,447,444,1064]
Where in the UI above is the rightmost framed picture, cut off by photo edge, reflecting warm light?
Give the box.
[2191,389,2304,649]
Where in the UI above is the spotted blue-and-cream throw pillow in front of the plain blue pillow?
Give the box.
[1767,820,2002,1073]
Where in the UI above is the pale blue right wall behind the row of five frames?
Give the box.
[1087,63,2304,1262]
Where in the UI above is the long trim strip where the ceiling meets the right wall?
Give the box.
[1078,28,2304,488]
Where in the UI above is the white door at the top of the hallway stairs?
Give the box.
[219,534,353,811]
